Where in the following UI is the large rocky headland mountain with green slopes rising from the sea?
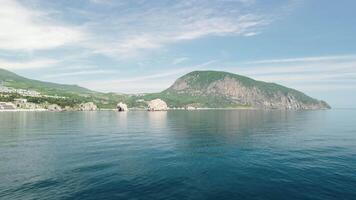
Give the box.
[145,71,330,110]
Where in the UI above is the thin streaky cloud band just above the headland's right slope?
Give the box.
[226,55,356,91]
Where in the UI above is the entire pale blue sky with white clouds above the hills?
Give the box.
[0,0,356,108]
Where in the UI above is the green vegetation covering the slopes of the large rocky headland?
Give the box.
[145,71,327,107]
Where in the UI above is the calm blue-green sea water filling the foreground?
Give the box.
[0,110,356,200]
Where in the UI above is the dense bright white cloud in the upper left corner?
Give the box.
[0,0,83,51]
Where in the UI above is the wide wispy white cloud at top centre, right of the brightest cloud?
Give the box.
[83,0,271,57]
